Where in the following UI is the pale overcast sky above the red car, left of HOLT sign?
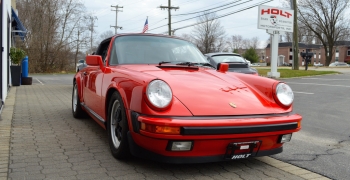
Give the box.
[81,0,284,47]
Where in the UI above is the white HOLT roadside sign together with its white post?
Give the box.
[258,6,294,78]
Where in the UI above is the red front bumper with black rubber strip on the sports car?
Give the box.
[128,112,302,163]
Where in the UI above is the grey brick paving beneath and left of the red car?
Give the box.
[0,84,327,180]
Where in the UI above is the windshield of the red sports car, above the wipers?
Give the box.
[110,35,208,64]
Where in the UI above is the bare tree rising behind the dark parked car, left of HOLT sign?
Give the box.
[191,12,225,53]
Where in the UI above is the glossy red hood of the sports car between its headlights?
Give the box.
[121,65,286,116]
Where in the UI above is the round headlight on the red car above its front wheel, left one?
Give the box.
[146,80,173,108]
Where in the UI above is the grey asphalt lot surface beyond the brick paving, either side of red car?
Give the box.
[26,69,350,180]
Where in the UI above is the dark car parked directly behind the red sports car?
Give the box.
[205,52,259,75]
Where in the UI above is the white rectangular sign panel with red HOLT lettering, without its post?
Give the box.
[258,6,294,32]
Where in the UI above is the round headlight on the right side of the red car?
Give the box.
[276,83,294,106]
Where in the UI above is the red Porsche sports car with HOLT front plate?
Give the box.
[72,34,302,163]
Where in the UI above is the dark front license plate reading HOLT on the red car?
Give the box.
[225,141,261,159]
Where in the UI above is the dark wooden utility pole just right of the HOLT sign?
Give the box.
[290,0,299,70]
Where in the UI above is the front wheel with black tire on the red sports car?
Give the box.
[106,92,130,159]
